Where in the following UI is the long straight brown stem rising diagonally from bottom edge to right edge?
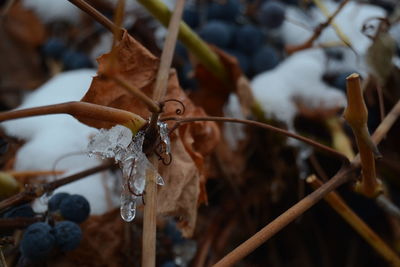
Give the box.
[214,101,400,267]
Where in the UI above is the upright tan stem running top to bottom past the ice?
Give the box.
[142,0,185,267]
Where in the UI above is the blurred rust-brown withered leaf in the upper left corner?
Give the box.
[0,3,46,99]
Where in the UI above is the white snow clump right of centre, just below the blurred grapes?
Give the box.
[251,48,346,130]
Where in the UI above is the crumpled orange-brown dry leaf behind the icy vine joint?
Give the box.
[80,32,219,236]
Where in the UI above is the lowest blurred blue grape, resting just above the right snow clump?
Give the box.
[251,46,279,74]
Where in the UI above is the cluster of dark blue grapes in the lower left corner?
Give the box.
[17,193,90,261]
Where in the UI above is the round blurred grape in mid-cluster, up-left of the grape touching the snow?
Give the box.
[235,24,264,54]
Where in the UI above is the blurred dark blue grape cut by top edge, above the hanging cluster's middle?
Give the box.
[207,0,243,22]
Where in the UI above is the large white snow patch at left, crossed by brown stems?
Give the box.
[1,69,115,214]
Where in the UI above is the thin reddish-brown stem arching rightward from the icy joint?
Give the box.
[161,116,349,164]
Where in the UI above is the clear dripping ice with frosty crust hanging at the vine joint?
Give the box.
[88,123,170,222]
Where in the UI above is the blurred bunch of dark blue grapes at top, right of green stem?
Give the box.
[175,0,293,86]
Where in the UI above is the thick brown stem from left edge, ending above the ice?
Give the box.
[0,101,146,132]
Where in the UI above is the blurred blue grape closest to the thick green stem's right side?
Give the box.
[199,20,234,47]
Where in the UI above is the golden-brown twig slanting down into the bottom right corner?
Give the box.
[306,175,400,267]
